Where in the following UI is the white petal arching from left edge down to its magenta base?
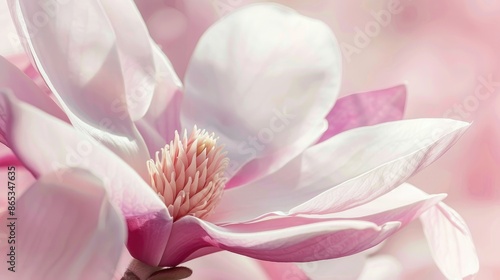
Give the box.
[0,92,172,265]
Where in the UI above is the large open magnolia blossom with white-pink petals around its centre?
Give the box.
[0,0,477,278]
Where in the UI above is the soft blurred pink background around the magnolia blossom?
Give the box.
[0,0,500,280]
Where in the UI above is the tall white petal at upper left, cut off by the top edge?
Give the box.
[11,0,149,178]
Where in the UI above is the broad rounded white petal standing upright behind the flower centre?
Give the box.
[181,3,341,187]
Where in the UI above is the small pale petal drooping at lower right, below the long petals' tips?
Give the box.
[420,203,479,279]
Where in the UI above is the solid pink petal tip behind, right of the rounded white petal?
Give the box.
[318,85,406,143]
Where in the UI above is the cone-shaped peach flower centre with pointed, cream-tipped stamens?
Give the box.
[147,126,229,221]
